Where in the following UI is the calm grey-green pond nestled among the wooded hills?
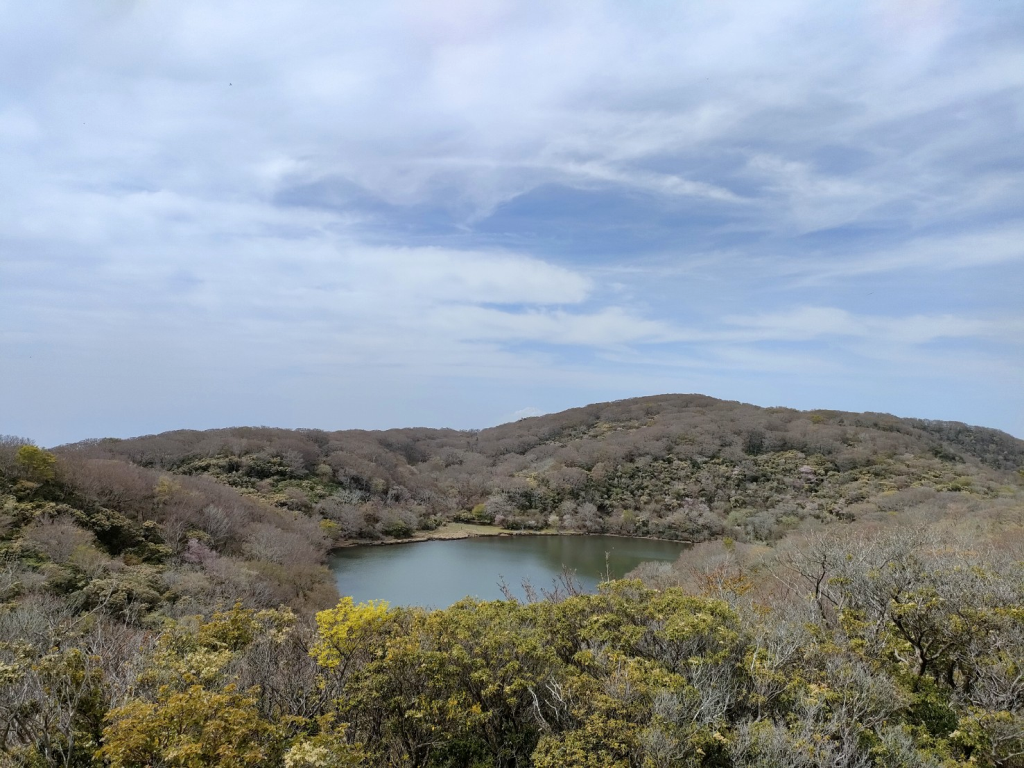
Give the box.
[330,536,688,607]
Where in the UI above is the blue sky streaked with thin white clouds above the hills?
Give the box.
[0,0,1024,445]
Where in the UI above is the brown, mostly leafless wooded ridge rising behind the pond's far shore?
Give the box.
[57,395,1024,541]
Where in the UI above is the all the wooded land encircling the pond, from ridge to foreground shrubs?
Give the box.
[0,395,1024,768]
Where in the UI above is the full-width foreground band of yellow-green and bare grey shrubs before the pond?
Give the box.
[6,565,1024,768]
